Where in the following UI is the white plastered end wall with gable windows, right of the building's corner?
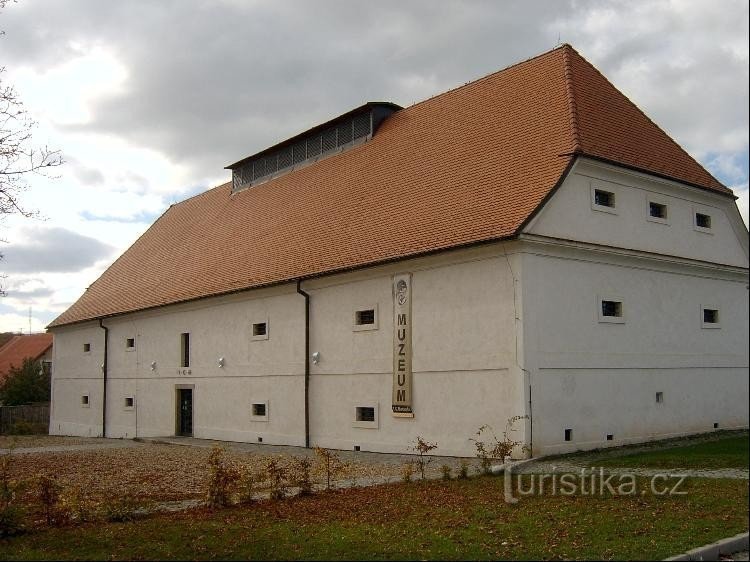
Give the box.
[523,156,748,450]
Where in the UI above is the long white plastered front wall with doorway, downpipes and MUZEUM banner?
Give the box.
[50,244,524,455]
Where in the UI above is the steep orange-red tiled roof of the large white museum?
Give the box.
[50,45,732,326]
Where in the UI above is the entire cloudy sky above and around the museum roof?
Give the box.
[0,0,748,331]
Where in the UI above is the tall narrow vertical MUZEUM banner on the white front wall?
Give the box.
[392,273,414,418]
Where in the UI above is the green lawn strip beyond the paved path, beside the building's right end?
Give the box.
[595,435,750,469]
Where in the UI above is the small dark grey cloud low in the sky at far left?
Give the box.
[0,227,114,273]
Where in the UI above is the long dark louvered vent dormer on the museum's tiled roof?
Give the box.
[227,102,401,191]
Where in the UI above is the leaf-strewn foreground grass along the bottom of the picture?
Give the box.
[0,477,748,560]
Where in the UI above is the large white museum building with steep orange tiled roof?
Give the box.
[50,45,748,455]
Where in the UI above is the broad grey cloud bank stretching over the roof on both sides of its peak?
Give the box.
[0,0,748,186]
